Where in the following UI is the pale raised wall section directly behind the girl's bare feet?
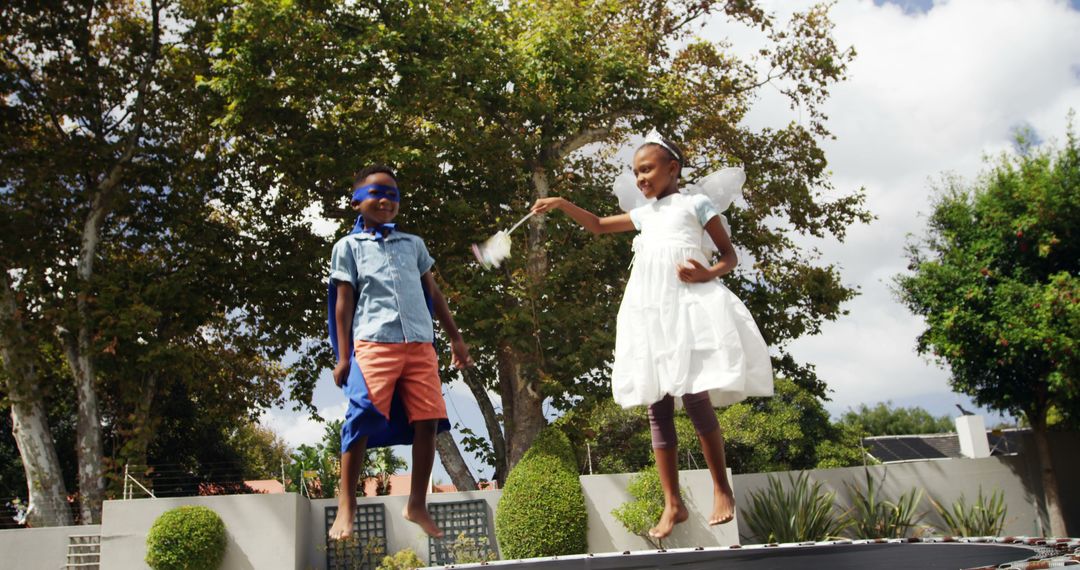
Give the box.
[581,470,739,553]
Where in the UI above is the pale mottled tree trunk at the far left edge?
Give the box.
[0,268,71,527]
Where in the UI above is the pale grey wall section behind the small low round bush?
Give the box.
[102,493,310,570]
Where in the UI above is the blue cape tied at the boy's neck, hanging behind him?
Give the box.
[326,218,450,453]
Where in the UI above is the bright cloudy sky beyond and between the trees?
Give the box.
[264,0,1080,481]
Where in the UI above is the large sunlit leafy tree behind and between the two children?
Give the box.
[207,0,868,480]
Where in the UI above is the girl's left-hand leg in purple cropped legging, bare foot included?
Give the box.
[649,396,690,539]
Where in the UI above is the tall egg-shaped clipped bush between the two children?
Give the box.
[495,428,589,558]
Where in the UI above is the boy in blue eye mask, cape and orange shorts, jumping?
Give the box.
[321,165,472,540]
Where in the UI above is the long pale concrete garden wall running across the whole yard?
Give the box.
[0,434,1080,570]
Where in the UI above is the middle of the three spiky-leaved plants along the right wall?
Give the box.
[843,470,923,539]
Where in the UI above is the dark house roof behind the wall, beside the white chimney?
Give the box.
[863,428,1030,463]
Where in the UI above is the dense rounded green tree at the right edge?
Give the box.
[896,122,1080,537]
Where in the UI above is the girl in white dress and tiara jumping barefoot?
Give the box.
[532,137,772,539]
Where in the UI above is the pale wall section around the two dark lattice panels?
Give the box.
[298,490,502,570]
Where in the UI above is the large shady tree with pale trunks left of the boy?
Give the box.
[0,0,321,525]
